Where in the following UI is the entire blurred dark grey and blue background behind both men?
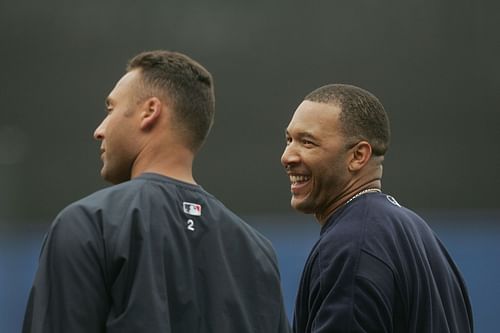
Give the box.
[0,0,500,333]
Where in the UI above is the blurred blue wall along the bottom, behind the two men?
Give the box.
[0,212,500,333]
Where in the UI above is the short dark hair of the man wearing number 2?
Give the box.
[127,50,215,152]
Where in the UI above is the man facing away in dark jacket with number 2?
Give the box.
[23,51,289,333]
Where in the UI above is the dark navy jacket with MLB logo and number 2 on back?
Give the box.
[23,174,289,333]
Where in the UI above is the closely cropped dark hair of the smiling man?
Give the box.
[304,84,390,156]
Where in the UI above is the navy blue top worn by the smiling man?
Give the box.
[293,193,473,333]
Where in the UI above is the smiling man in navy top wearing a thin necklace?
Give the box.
[281,84,473,333]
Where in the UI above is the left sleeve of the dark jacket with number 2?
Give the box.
[23,206,109,333]
